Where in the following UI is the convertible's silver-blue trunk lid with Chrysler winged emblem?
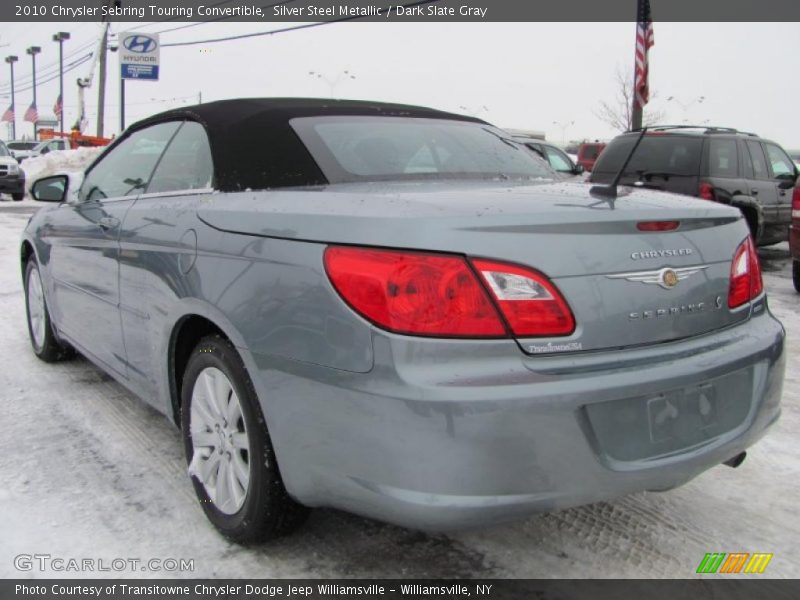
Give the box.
[199,182,748,354]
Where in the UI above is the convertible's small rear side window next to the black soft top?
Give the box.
[147,121,214,194]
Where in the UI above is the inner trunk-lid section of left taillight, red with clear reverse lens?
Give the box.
[472,259,575,337]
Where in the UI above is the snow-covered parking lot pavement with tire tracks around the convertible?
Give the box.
[0,209,800,578]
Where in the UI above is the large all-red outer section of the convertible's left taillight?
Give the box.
[325,246,506,337]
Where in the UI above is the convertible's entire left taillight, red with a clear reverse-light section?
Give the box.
[325,246,575,338]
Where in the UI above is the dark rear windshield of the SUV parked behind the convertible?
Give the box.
[594,134,703,175]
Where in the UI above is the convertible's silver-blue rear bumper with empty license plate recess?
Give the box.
[248,302,784,530]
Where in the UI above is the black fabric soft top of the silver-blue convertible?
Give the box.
[129,98,483,192]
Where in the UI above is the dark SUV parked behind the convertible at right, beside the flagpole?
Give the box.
[590,126,798,246]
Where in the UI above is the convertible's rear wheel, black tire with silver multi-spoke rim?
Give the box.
[181,335,308,544]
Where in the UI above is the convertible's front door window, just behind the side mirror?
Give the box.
[78,121,180,202]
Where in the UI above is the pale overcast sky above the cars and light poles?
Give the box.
[0,22,800,148]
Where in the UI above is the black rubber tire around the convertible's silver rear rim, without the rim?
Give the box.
[181,335,309,544]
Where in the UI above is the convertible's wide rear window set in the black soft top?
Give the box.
[291,116,555,183]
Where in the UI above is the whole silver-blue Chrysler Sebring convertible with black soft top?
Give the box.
[21,99,784,542]
